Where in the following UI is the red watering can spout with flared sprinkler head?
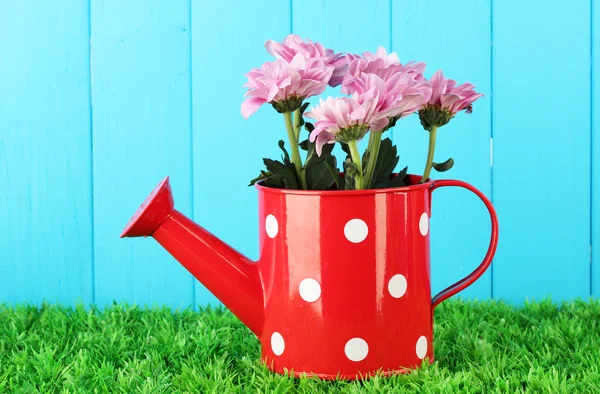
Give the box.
[121,177,264,337]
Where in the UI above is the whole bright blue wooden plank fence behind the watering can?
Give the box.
[0,0,600,307]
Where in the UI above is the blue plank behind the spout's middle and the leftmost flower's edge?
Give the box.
[192,0,290,305]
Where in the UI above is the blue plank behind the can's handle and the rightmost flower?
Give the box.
[392,0,492,299]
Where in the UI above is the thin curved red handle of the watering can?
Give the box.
[431,179,498,310]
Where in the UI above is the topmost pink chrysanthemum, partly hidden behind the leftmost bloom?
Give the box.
[265,34,347,87]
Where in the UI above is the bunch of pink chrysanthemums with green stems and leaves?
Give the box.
[241,34,483,190]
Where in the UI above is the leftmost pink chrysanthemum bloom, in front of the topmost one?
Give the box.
[241,53,334,119]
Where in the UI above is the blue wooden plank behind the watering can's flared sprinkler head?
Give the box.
[91,0,193,307]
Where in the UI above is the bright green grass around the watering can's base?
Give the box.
[0,300,600,394]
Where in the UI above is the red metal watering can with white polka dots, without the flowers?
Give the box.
[121,175,498,379]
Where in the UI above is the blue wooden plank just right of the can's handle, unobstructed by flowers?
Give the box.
[493,0,590,303]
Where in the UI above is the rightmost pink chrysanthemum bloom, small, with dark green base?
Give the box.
[419,70,483,130]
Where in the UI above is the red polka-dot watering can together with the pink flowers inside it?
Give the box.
[122,35,498,379]
